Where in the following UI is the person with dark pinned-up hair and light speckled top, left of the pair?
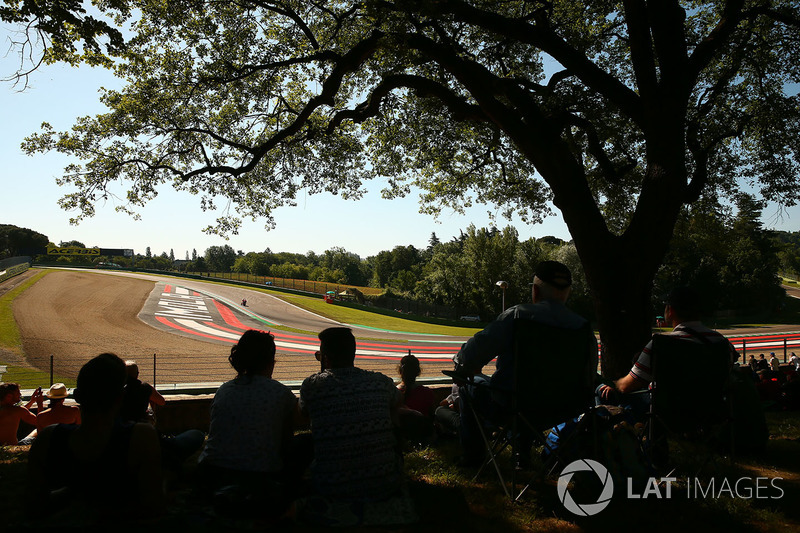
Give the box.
[199,330,298,504]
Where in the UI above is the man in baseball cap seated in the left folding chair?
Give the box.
[453,261,597,465]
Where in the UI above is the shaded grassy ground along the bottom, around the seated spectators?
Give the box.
[0,412,800,533]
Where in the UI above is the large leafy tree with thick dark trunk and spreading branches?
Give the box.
[20,0,800,377]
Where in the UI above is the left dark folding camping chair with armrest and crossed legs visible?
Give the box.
[444,318,597,500]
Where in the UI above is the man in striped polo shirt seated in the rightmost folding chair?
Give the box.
[597,287,739,400]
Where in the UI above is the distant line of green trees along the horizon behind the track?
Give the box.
[0,194,800,320]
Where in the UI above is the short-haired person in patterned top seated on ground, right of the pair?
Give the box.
[299,328,402,502]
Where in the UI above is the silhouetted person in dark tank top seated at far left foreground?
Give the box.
[28,353,164,528]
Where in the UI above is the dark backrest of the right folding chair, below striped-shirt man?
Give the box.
[644,335,734,469]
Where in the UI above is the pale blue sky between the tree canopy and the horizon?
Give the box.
[0,32,800,259]
